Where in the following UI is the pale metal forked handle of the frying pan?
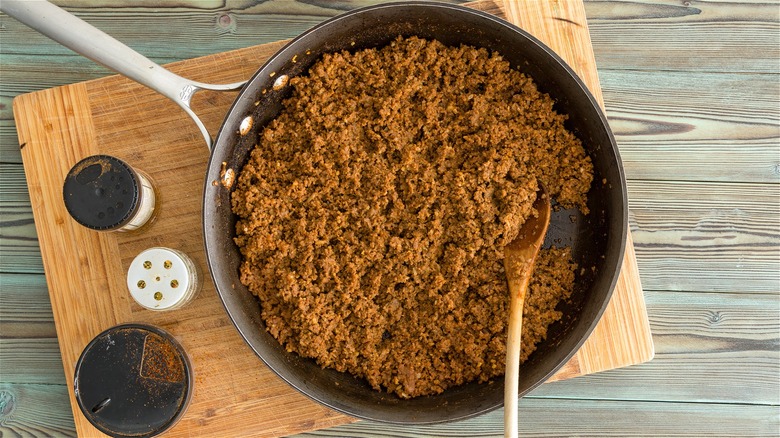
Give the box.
[0,0,246,149]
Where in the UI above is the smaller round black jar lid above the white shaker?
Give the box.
[62,155,140,230]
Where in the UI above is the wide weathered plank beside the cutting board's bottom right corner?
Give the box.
[531,291,780,406]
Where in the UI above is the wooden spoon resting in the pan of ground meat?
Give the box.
[504,183,550,438]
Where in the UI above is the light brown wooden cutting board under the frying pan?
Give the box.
[14,0,653,436]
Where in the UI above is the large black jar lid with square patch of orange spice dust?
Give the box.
[74,324,192,437]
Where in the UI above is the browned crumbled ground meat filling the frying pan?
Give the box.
[232,37,592,398]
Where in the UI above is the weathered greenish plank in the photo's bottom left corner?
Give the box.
[0,383,76,437]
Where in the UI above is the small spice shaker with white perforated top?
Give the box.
[127,247,200,310]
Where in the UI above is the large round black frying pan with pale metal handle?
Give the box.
[0,0,628,424]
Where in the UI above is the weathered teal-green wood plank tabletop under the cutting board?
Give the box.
[0,0,780,437]
